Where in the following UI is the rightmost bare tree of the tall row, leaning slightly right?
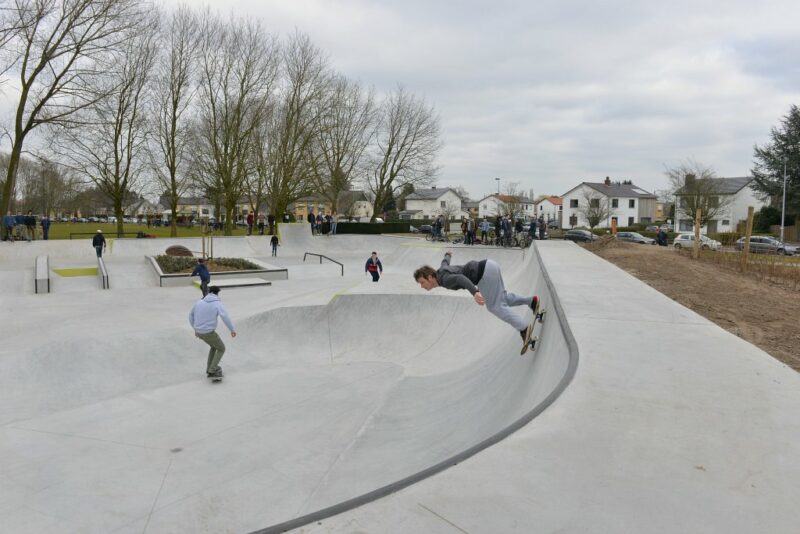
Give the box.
[367,87,442,221]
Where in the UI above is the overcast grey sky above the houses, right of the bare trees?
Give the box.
[6,0,800,199]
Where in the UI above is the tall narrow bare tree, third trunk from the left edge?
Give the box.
[151,6,199,237]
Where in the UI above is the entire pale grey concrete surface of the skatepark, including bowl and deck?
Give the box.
[0,224,800,533]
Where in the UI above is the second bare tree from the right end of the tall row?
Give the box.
[312,76,376,216]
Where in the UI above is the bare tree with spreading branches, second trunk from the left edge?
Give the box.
[55,21,158,232]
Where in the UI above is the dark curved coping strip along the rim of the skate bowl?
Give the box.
[251,241,578,534]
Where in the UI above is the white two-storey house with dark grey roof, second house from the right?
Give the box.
[561,178,656,228]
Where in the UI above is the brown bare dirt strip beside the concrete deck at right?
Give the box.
[589,241,800,371]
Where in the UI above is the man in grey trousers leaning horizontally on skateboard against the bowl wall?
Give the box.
[414,252,539,341]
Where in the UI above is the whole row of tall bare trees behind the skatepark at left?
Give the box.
[0,0,442,235]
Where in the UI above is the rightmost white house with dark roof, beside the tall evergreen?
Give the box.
[675,176,767,234]
